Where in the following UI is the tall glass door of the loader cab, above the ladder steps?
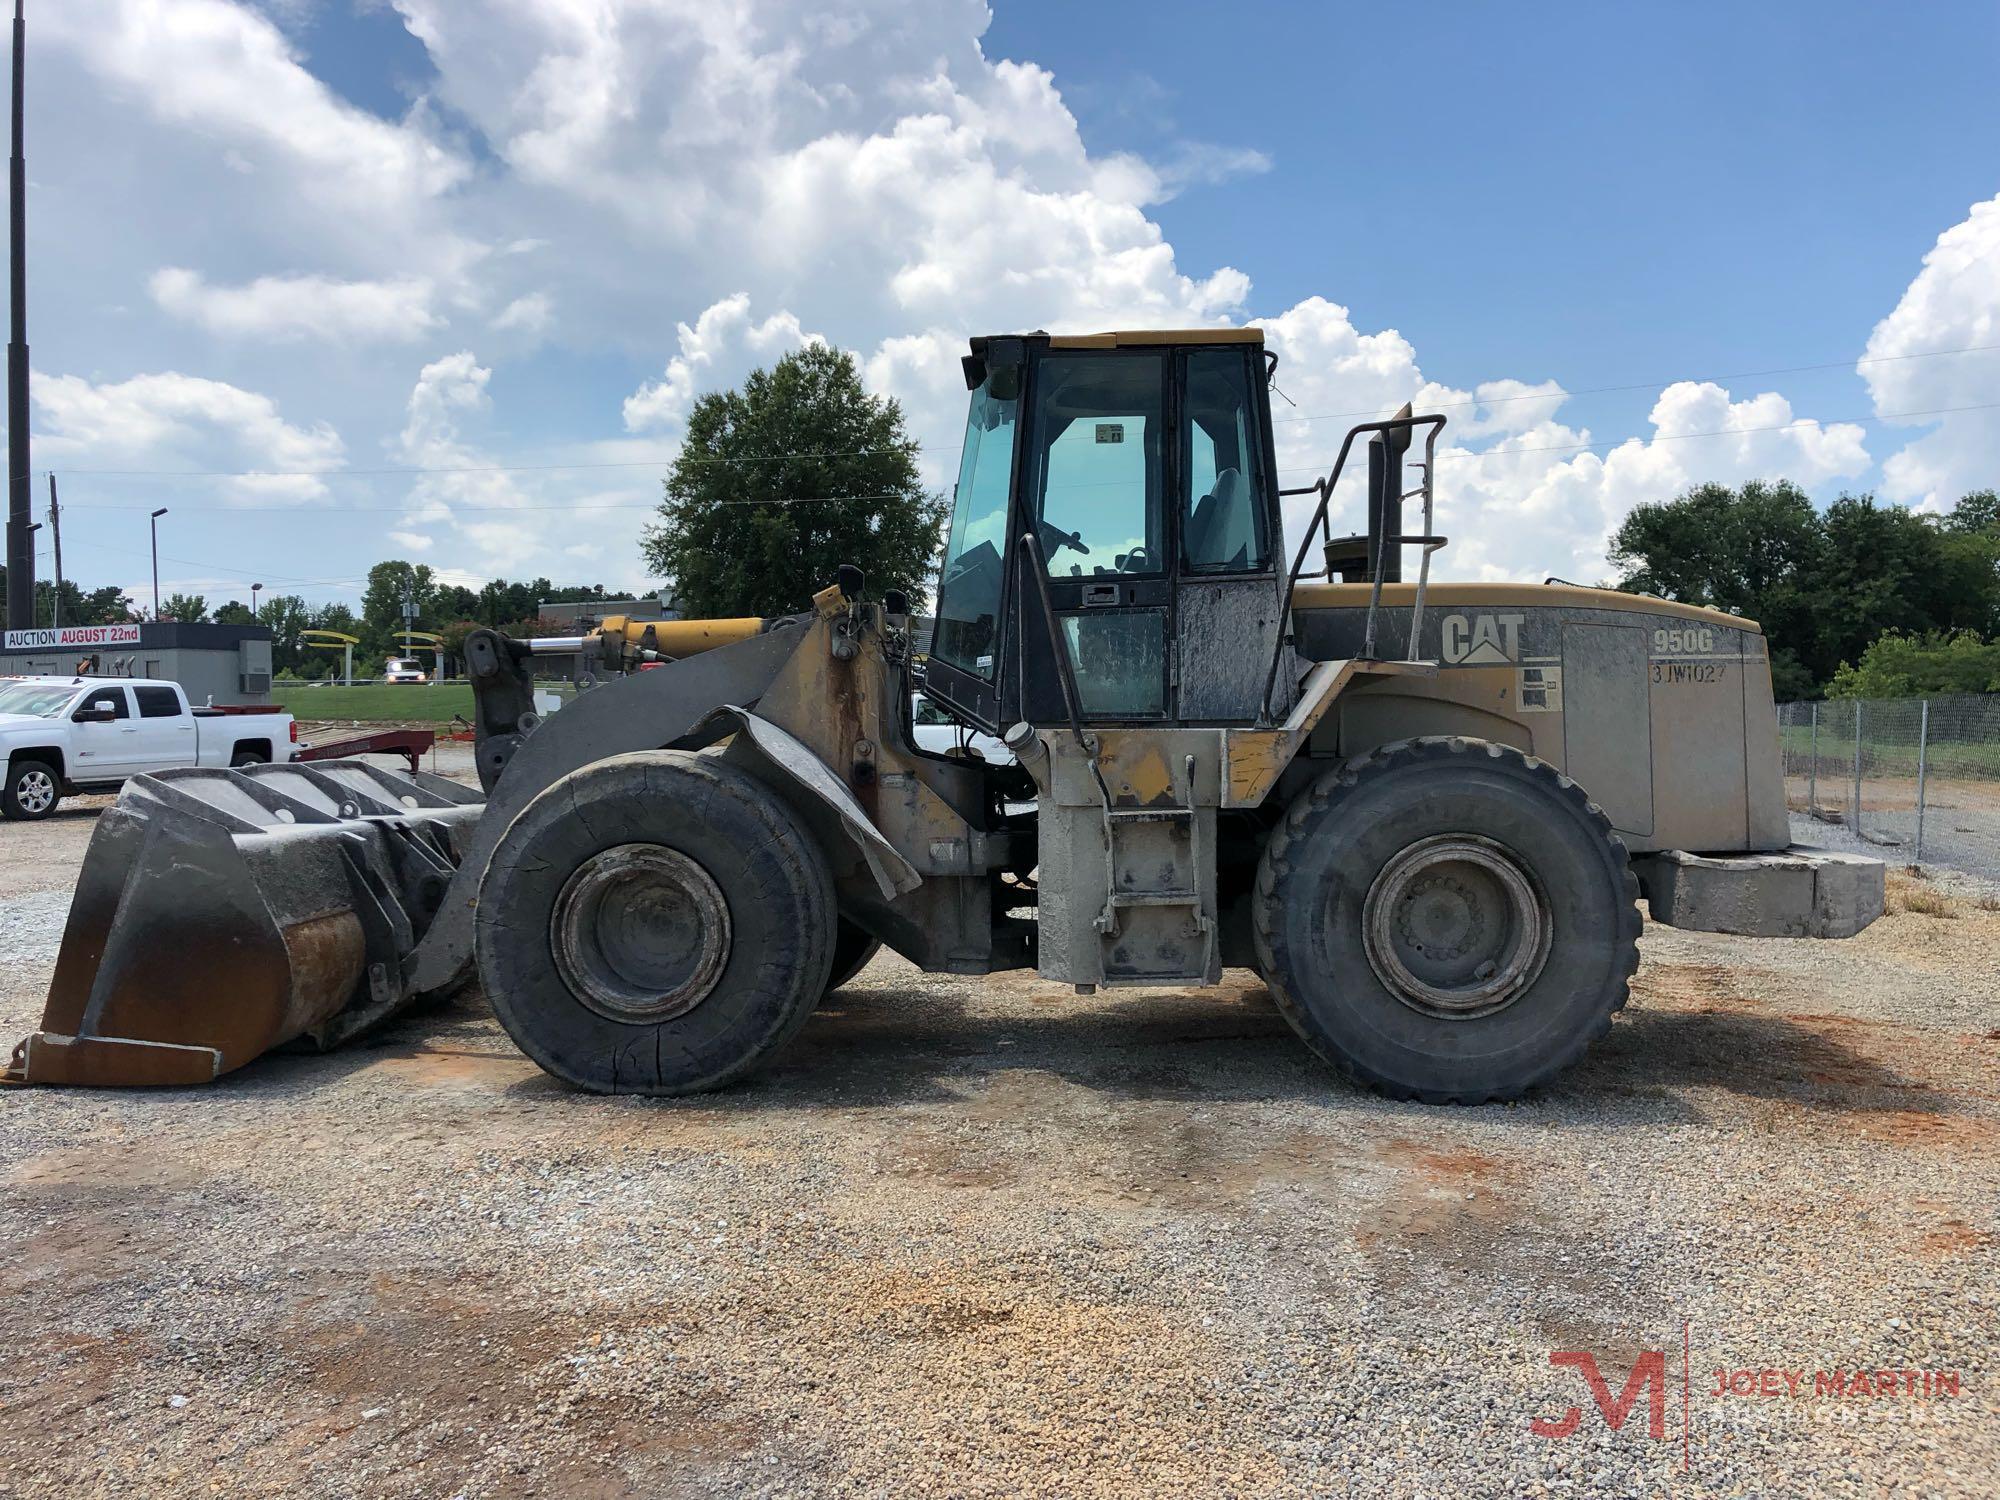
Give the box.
[1020,348,1174,724]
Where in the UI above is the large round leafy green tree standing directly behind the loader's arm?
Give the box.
[642,344,946,618]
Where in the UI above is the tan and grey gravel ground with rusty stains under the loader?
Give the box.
[0,768,2000,1496]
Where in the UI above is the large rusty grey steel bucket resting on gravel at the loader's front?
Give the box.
[6,760,484,1084]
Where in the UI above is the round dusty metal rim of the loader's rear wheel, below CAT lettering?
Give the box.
[1362,834,1552,1020]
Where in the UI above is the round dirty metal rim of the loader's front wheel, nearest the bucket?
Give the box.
[550,844,730,1022]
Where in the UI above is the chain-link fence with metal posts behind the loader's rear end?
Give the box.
[1778,694,2000,880]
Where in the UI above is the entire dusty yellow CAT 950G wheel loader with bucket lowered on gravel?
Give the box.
[10,328,1882,1104]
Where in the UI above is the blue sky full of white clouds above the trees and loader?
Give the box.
[15,0,2000,604]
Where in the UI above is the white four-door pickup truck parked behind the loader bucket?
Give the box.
[0,678,298,818]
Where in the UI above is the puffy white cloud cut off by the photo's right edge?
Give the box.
[1860,196,2000,510]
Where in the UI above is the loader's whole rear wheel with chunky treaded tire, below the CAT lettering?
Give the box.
[1252,738,1640,1104]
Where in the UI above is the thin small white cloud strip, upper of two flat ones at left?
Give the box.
[148,266,444,344]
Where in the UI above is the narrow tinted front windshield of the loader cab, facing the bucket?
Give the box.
[930,376,1020,682]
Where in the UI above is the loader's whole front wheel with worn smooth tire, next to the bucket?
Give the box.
[474,750,838,1094]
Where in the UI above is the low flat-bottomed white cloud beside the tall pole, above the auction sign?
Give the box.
[30,370,346,504]
